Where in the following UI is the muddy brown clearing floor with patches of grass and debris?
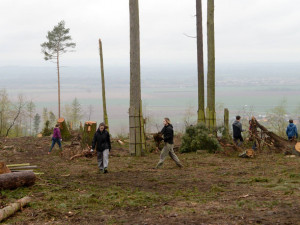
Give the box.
[0,137,300,225]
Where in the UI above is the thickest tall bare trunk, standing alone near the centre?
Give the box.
[129,0,142,156]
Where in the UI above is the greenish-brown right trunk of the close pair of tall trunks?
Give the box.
[206,0,216,129]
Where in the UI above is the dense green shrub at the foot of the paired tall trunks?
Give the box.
[180,124,222,153]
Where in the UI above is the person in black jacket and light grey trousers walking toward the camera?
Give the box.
[91,123,111,173]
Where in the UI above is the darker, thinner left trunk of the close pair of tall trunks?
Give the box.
[196,0,205,123]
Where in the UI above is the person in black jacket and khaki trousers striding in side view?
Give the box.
[156,118,182,168]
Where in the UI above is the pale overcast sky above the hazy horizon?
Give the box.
[0,0,300,66]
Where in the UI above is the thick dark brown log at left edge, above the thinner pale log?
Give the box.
[0,171,36,190]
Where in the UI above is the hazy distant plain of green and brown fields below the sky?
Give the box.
[0,65,300,133]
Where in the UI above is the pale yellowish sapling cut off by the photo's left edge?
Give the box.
[0,89,11,136]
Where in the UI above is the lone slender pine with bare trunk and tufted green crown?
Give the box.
[41,21,76,118]
